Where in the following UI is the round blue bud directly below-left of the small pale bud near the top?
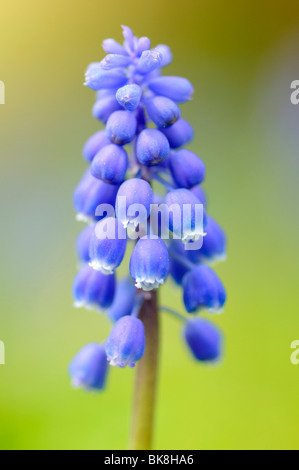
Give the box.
[106,111,137,145]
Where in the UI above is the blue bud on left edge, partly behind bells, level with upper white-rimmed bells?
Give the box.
[74,169,119,221]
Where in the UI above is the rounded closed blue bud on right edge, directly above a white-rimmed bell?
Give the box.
[169,149,206,188]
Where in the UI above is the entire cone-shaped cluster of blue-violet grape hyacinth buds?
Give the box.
[70,26,226,390]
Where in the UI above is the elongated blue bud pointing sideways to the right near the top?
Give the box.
[148,76,194,103]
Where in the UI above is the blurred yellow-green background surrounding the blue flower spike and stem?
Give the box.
[0,0,299,450]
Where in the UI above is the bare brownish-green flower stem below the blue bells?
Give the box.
[130,291,159,450]
